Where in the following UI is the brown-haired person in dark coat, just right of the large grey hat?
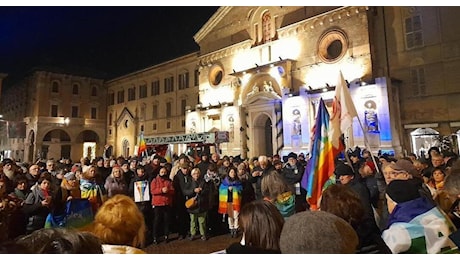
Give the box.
[320,185,391,254]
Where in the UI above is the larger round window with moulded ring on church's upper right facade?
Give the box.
[318,30,348,63]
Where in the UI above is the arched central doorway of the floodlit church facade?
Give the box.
[253,113,273,156]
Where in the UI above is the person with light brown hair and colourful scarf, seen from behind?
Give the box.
[261,171,295,218]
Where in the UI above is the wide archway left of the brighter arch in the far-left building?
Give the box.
[40,129,71,159]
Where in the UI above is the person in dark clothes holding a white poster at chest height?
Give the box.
[128,165,153,244]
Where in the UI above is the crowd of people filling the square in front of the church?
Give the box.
[0,148,460,254]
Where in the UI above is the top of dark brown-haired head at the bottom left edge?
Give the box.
[15,228,104,254]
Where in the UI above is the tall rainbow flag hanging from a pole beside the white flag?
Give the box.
[301,98,337,210]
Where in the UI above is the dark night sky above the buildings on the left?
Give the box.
[0,6,218,79]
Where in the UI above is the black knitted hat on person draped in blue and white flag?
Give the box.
[386,180,421,203]
